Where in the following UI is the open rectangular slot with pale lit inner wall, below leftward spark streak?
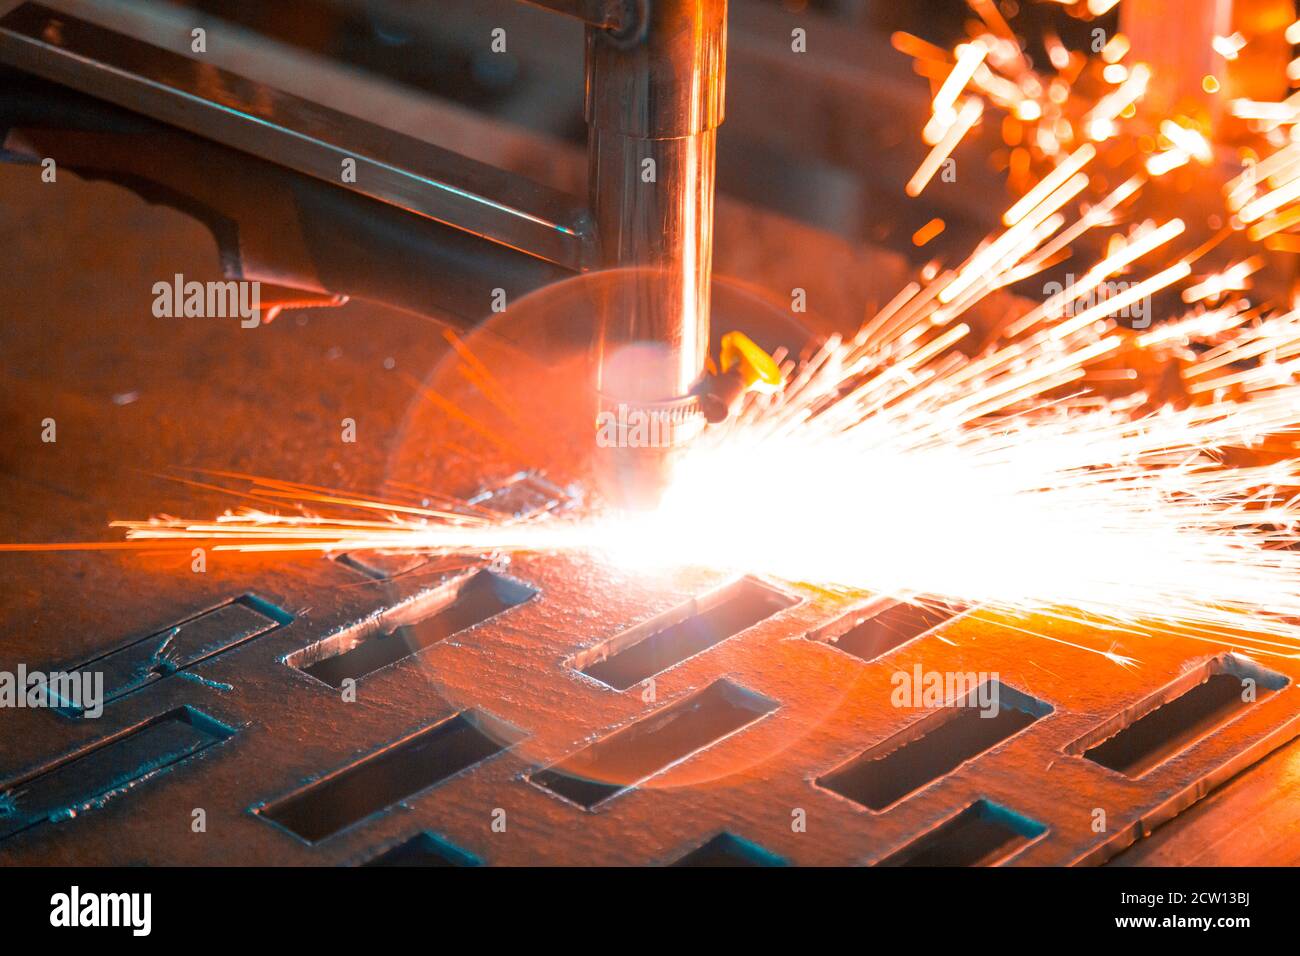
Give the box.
[285,571,537,687]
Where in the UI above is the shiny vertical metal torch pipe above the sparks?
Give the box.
[586,0,727,452]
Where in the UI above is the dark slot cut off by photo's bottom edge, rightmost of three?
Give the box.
[876,800,1047,866]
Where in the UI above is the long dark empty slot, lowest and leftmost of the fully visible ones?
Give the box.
[256,713,519,843]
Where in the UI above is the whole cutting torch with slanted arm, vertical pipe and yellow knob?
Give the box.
[0,0,780,506]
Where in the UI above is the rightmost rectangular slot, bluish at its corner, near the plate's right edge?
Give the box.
[1069,654,1287,777]
